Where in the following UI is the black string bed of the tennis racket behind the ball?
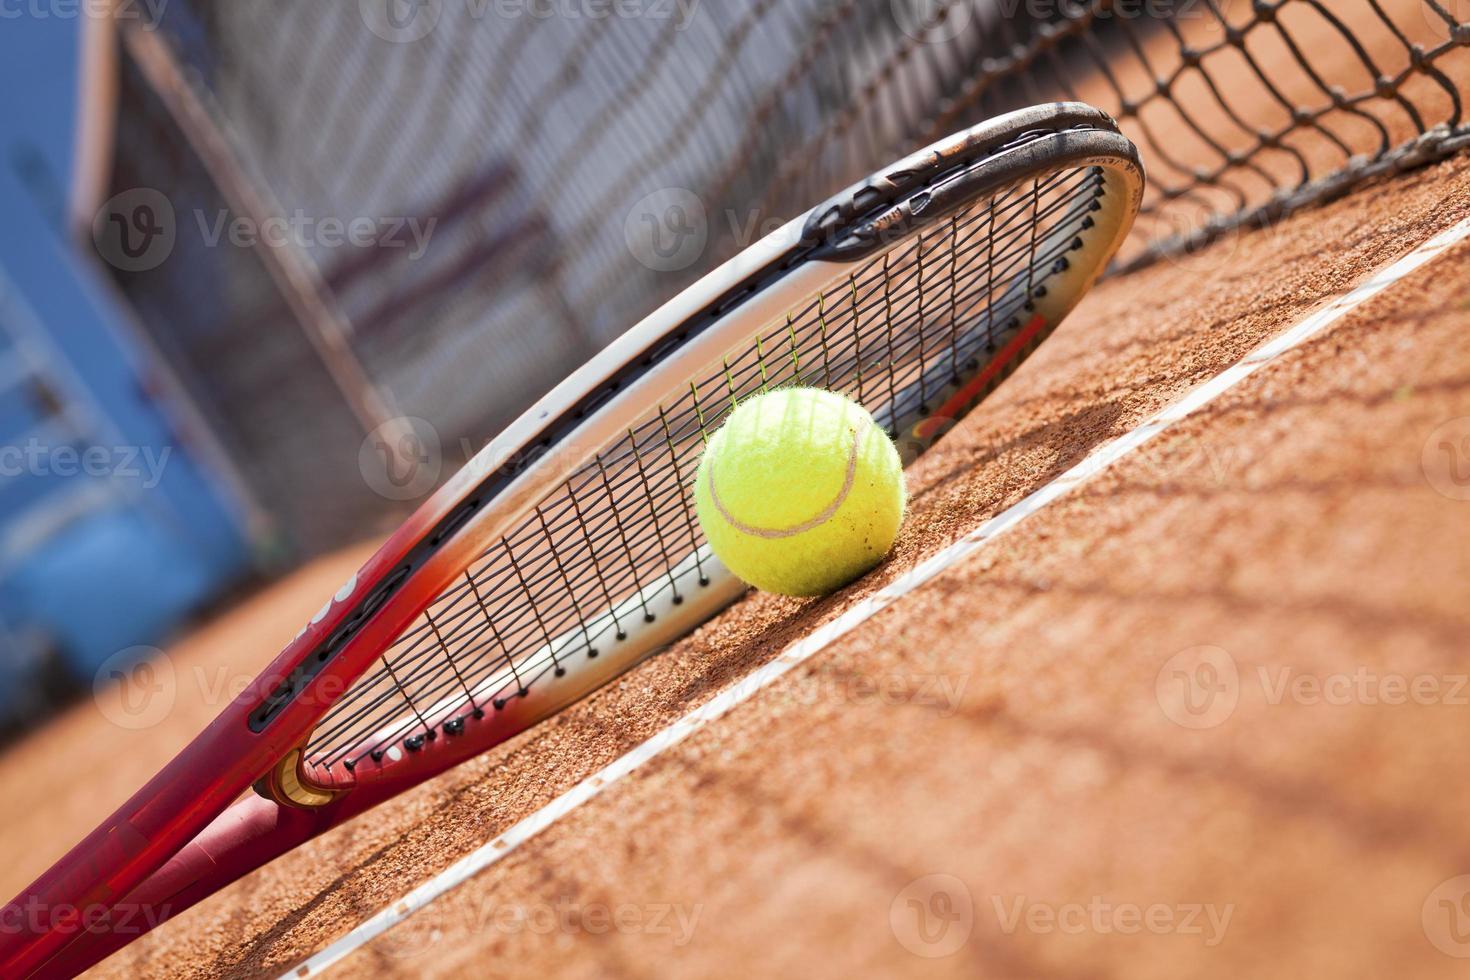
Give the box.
[306,167,1104,770]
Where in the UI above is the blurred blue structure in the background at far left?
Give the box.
[0,16,250,721]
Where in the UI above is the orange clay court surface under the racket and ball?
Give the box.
[0,141,1470,977]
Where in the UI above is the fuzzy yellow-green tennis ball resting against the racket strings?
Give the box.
[694,388,906,595]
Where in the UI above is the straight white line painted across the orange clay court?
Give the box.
[282,219,1470,980]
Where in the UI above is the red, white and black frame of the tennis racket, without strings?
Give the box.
[0,103,1144,976]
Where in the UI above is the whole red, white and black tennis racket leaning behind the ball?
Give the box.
[0,103,1144,977]
